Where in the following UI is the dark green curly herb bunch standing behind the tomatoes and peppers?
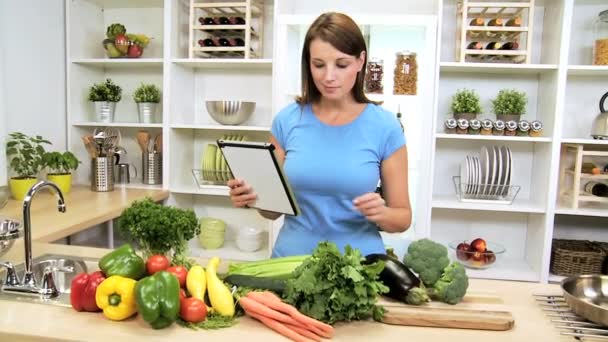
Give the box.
[118,198,200,267]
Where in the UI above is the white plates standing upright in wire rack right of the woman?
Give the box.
[459,146,513,199]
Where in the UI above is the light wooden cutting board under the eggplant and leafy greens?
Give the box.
[378,293,515,330]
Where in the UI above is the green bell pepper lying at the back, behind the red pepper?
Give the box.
[99,243,146,280]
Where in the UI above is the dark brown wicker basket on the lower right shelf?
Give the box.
[551,239,606,276]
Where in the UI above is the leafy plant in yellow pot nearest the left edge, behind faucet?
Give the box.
[6,132,52,201]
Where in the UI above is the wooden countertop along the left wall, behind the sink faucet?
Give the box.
[0,186,169,242]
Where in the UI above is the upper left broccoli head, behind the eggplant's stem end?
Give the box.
[403,239,450,287]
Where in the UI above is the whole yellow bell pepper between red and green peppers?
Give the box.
[95,275,137,321]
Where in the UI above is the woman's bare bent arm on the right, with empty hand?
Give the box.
[353,146,412,233]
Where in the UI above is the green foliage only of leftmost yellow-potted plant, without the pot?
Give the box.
[6,132,52,179]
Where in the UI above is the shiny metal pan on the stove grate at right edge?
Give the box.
[560,274,608,326]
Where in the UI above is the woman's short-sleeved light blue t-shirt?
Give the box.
[271,103,405,257]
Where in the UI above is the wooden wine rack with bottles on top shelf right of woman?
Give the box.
[456,0,534,63]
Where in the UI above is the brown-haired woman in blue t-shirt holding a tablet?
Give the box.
[228,13,412,257]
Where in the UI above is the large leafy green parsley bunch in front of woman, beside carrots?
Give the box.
[283,241,388,324]
